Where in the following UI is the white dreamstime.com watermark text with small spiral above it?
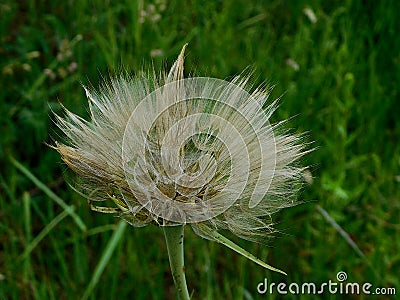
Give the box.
[257,271,396,295]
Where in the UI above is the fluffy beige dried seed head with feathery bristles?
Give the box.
[54,47,305,244]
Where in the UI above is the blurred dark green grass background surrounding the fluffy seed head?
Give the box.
[0,0,400,299]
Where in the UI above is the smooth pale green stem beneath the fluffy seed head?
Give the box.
[163,225,190,300]
